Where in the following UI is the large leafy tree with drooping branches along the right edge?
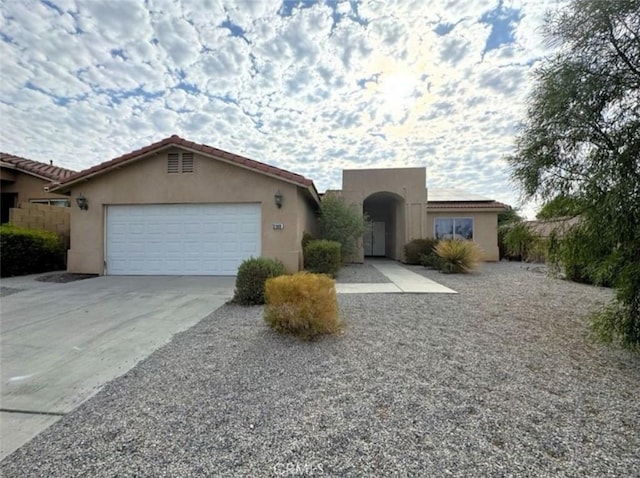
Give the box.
[509,0,640,347]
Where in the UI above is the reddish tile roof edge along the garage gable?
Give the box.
[55,134,318,193]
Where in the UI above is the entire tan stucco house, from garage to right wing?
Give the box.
[50,135,505,275]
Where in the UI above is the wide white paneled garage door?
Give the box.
[105,204,261,275]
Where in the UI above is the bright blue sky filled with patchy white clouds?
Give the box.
[0,0,566,215]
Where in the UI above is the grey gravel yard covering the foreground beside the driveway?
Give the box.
[1,263,640,477]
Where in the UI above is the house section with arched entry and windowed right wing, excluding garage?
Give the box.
[341,168,507,261]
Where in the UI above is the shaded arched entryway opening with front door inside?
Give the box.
[362,191,405,260]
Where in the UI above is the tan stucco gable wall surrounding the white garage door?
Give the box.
[68,148,312,274]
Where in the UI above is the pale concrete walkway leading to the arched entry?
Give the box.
[336,261,457,294]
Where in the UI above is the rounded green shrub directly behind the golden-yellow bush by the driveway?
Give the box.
[233,257,287,305]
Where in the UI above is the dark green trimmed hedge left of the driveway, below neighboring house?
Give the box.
[0,224,65,277]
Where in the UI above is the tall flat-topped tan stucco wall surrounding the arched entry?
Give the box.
[342,168,427,262]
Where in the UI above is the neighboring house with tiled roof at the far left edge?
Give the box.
[0,153,75,224]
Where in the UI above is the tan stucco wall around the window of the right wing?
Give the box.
[427,209,500,261]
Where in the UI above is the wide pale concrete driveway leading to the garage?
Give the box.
[0,274,235,459]
